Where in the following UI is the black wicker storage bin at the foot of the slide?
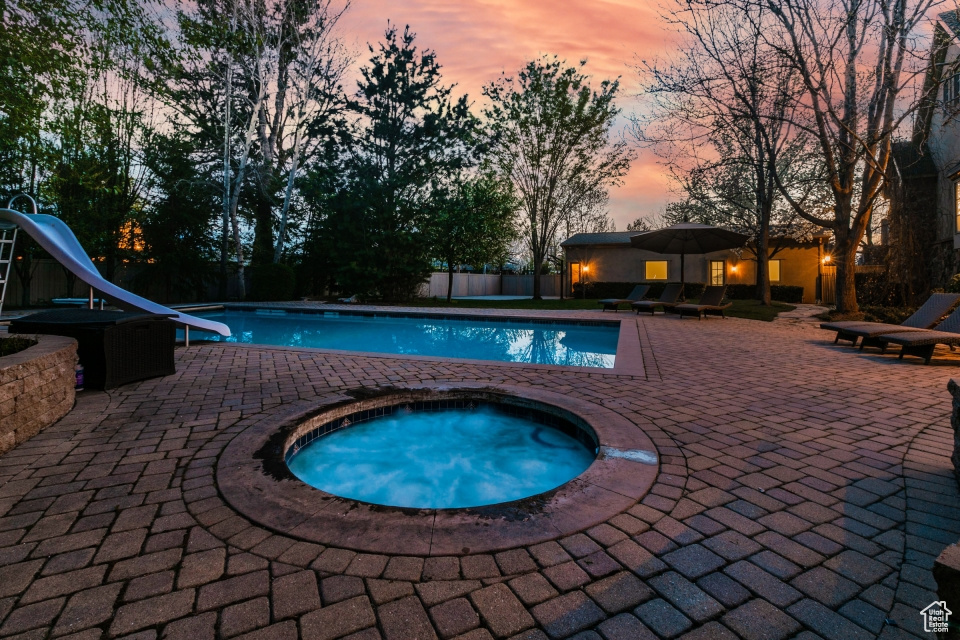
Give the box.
[10,309,176,389]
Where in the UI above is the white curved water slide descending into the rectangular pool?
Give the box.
[0,209,230,336]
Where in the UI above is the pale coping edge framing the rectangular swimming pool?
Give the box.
[180,303,647,378]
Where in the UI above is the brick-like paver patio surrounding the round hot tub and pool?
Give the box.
[0,311,960,640]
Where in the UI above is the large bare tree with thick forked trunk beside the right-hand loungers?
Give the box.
[760,0,940,313]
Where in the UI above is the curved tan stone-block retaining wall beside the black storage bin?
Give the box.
[0,334,77,454]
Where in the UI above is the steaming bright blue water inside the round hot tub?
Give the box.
[287,406,594,509]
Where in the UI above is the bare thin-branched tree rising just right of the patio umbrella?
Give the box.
[633,0,820,304]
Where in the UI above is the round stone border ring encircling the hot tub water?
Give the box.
[216,383,659,556]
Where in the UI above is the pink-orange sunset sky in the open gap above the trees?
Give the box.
[341,0,669,231]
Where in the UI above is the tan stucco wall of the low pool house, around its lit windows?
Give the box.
[565,245,820,304]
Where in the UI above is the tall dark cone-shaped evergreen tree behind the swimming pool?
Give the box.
[312,26,476,300]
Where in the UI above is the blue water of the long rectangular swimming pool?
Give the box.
[190,310,620,368]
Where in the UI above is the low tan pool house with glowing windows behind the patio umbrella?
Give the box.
[560,231,827,304]
